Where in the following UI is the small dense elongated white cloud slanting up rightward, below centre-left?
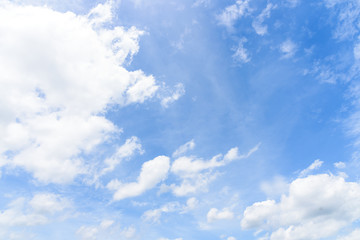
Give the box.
[107,156,170,200]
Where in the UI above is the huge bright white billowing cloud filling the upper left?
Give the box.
[0,1,173,183]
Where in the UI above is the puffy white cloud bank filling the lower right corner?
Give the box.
[241,174,360,240]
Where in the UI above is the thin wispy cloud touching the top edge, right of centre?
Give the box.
[217,0,251,29]
